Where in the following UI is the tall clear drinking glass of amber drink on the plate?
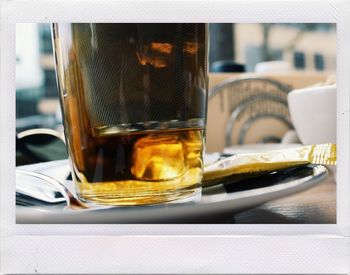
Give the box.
[52,23,207,205]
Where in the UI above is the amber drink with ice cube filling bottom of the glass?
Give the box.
[66,129,203,205]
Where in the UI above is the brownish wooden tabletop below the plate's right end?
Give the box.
[230,172,336,224]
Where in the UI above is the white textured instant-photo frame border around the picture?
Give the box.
[0,0,350,274]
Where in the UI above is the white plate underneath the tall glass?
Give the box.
[16,161,327,224]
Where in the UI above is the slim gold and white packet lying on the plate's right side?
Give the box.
[203,144,337,187]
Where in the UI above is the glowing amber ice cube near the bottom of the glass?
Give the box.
[131,134,186,180]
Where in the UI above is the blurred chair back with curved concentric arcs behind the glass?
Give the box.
[208,78,293,147]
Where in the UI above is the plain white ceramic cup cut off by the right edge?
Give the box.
[288,85,337,145]
